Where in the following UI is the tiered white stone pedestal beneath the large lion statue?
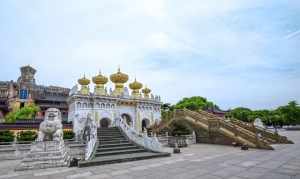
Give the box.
[15,141,70,171]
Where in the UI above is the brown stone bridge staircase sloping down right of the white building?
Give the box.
[159,109,290,150]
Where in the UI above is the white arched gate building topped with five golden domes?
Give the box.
[68,69,161,133]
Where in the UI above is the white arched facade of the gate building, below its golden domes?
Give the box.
[68,87,161,135]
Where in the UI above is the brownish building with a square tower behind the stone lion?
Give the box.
[0,65,70,119]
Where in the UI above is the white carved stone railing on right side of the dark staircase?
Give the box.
[116,118,162,152]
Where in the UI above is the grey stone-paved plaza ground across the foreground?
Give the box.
[0,131,300,179]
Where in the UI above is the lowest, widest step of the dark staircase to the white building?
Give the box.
[79,152,170,167]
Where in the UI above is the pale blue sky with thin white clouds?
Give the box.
[0,0,300,109]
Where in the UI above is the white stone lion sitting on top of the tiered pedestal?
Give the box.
[37,108,63,141]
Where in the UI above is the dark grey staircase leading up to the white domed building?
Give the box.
[79,127,170,167]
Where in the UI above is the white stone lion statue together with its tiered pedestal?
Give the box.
[15,108,70,171]
